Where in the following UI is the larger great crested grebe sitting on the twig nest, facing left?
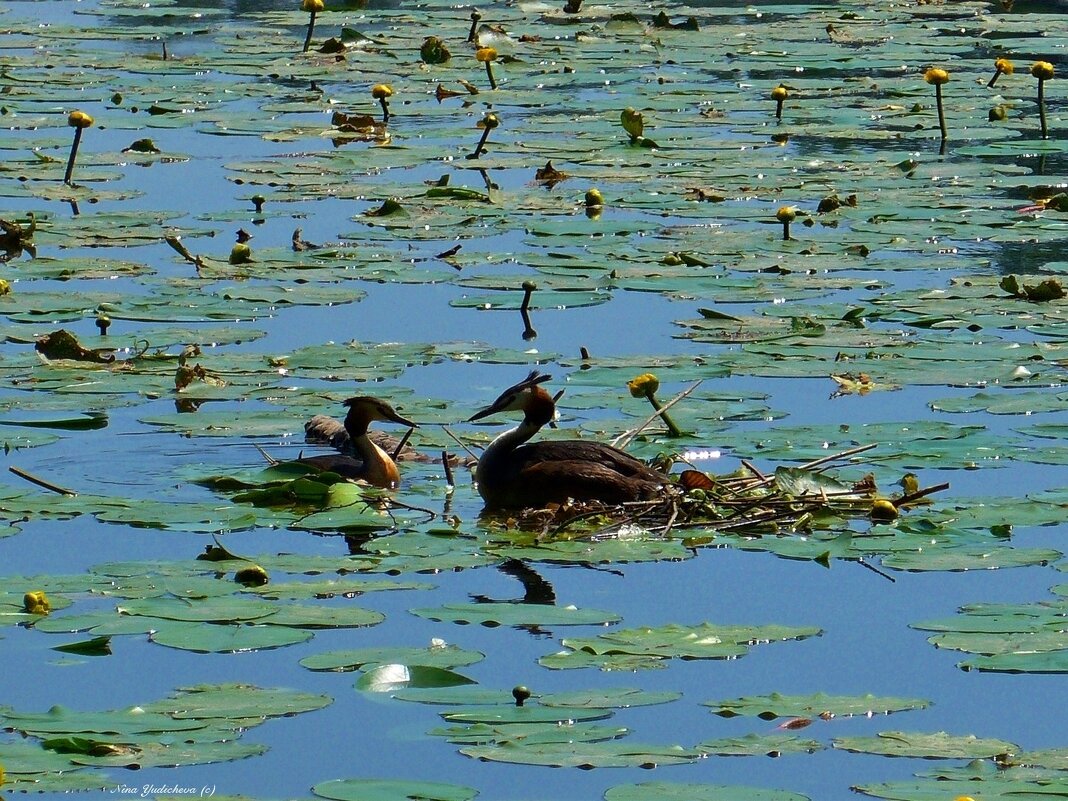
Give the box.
[468,371,671,508]
